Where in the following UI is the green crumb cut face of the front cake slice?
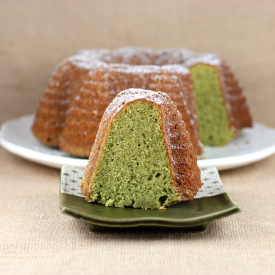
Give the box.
[90,101,179,209]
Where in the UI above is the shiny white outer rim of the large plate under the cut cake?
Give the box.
[0,114,275,171]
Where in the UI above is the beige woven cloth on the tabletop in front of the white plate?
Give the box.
[0,149,275,274]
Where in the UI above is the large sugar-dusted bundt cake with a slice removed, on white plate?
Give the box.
[32,48,252,157]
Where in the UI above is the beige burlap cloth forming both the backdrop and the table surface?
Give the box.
[0,0,275,274]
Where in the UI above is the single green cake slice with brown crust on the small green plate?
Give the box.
[81,89,202,209]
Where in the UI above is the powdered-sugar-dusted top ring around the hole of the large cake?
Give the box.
[68,48,192,74]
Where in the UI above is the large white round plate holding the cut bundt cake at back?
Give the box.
[0,115,275,170]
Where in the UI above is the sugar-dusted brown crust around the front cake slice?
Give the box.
[82,89,202,201]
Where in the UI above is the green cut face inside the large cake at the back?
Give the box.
[190,63,235,146]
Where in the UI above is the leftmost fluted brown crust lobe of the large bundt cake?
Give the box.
[32,59,96,146]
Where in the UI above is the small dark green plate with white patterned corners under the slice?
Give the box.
[60,165,241,232]
